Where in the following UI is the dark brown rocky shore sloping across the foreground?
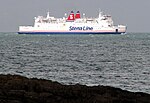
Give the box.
[0,75,150,103]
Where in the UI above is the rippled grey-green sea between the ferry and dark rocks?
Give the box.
[0,33,150,94]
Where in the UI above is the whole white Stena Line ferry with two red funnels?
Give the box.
[18,11,126,34]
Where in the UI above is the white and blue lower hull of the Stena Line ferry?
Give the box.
[18,26,126,34]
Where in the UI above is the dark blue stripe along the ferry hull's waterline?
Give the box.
[18,32,125,35]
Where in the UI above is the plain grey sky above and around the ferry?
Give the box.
[0,0,150,32]
